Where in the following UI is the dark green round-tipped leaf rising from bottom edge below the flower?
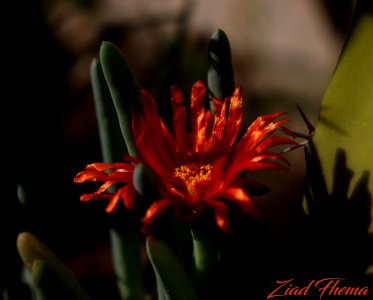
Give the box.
[146,236,198,300]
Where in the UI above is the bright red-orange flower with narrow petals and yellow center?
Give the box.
[75,81,295,233]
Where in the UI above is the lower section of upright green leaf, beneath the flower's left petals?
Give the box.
[110,226,146,300]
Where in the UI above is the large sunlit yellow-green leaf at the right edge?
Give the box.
[313,0,373,232]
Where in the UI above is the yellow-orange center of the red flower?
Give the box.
[174,163,212,195]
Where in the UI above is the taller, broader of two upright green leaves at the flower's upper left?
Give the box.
[100,41,140,156]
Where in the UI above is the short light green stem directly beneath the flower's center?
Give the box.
[191,220,220,288]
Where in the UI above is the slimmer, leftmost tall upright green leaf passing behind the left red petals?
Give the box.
[90,56,146,299]
